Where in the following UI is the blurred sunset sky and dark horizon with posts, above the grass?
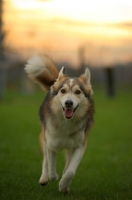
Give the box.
[0,0,132,99]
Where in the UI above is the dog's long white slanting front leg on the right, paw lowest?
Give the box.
[59,146,85,193]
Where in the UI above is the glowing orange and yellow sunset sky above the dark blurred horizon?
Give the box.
[4,0,132,64]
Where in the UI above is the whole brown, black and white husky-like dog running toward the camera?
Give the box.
[25,55,94,193]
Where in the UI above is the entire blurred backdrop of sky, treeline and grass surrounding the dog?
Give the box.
[0,0,132,200]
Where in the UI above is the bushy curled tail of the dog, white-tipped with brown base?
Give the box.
[25,55,59,90]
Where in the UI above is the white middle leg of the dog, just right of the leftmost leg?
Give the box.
[47,149,58,181]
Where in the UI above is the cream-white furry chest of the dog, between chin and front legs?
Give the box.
[46,120,84,152]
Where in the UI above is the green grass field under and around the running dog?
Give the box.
[0,89,132,200]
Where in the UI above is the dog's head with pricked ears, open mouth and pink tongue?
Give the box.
[51,67,93,119]
